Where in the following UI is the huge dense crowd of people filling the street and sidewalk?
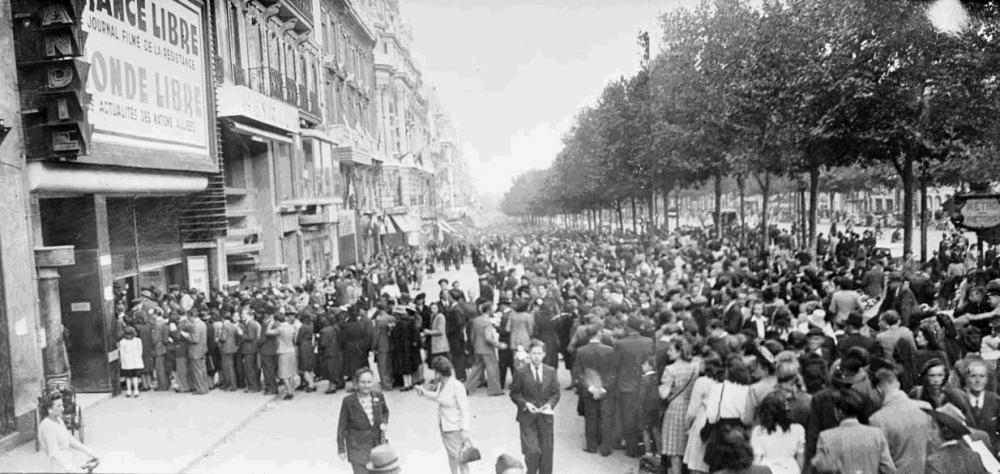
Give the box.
[43,217,1000,474]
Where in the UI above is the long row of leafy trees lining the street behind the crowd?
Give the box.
[502,0,1000,260]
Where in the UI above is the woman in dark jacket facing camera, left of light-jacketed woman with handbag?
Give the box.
[337,367,389,474]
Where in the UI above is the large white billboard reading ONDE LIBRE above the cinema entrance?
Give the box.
[82,0,215,160]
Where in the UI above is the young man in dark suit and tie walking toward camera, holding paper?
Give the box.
[510,340,560,474]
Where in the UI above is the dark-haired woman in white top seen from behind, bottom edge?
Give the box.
[750,390,806,474]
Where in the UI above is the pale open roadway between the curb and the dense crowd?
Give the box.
[184,263,638,474]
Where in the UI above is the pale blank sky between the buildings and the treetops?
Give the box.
[399,0,694,195]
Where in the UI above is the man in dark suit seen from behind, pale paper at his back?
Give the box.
[573,326,617,456]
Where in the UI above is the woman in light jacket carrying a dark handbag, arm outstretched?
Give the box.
[414,356,478,474]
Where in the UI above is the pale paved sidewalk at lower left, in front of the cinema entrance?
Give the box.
[0,390,273,473]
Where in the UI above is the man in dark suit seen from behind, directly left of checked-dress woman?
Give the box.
[613,317,654,457]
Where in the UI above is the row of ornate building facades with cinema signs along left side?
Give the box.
[0,0,476,449]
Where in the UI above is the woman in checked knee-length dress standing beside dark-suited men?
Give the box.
[659,337,698,474]
